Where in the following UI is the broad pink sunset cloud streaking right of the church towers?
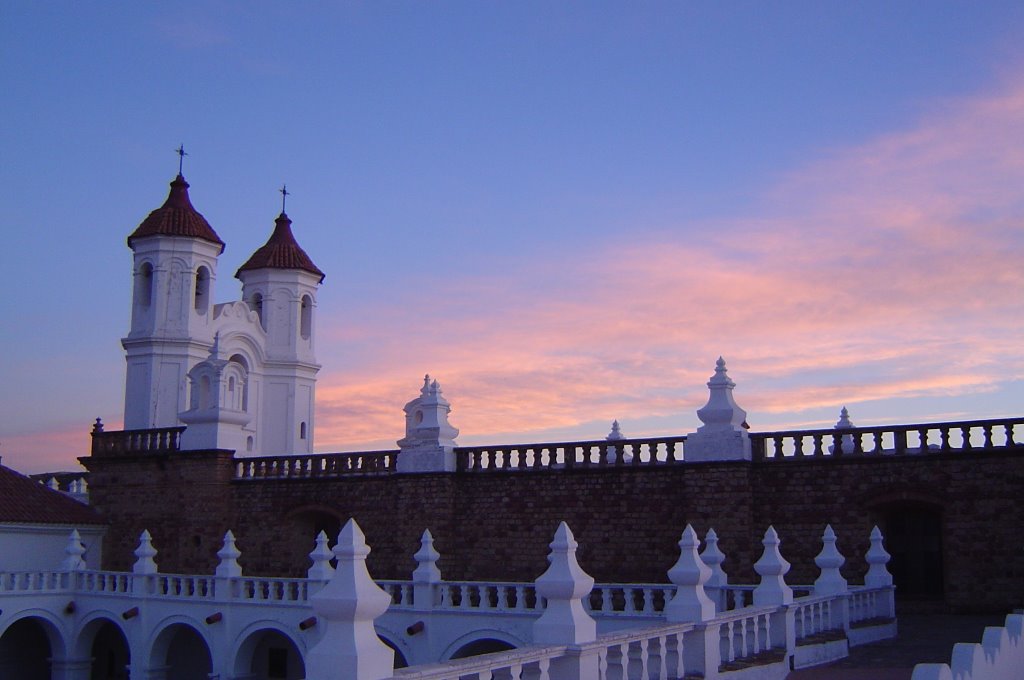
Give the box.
[317,75,1024,448]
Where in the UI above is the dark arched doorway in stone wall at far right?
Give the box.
[883,503,945,601]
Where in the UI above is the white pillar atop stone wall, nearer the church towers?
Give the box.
[395,375,459,472]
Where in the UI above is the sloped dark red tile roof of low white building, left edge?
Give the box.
[0,465,106,524]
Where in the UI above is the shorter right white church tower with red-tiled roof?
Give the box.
[234,206,324,454]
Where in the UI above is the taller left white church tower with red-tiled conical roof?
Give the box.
[121,173,224,430]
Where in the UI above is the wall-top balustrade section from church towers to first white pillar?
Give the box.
[234,451,398,479]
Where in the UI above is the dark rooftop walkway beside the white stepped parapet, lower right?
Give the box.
[786,604,1006,680]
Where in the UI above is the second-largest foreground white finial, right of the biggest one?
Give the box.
[534,522,597,644]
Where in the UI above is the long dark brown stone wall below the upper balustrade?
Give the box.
[77,448,1024,611]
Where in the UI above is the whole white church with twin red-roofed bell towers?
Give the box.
[122,165,324,455]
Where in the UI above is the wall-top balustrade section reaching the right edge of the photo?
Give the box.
[750,418,1024,461]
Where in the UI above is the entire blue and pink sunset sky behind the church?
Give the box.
[0,0,1024,472]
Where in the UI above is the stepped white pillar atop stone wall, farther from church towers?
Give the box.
[683,356,751,463]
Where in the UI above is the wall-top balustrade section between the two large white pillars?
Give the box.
[455,435,686,472]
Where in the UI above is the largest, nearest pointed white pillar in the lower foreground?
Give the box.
[306,519,394,680]
